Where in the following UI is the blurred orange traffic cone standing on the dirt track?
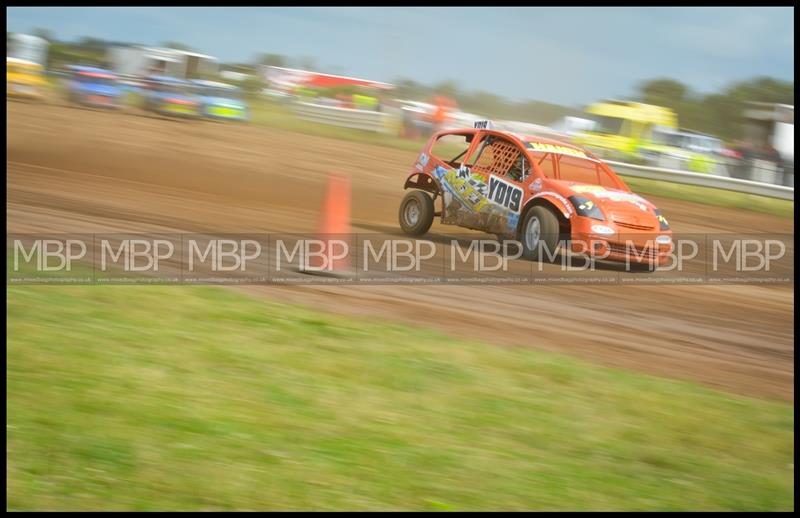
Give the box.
[304,174,350,275]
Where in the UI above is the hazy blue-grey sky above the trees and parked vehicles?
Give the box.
[6,7,794,105]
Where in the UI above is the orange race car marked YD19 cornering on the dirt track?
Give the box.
[400,121,672,268]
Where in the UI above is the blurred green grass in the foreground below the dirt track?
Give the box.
[6,286,794,510]
